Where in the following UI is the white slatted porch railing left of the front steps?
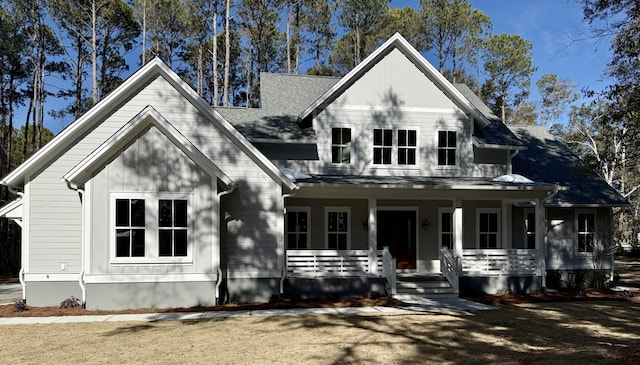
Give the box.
[286,250,382,277]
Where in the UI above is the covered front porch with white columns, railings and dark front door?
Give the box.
[284,177,559,294]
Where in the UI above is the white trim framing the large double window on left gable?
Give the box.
[108,192,194,265]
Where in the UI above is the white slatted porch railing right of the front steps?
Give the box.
[460,249,540,276]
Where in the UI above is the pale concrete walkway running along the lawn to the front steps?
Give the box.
[0,295,495,325]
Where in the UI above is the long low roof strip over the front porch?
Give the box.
[296,175,565,192]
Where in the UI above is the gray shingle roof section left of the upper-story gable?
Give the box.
[216,73,339,142]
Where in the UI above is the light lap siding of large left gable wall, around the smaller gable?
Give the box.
[29,77,281,273]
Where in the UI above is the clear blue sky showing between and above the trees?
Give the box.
[37,0,610,134]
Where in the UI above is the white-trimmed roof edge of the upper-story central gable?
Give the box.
[298,33,489,127]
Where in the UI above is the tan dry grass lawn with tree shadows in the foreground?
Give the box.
[0,299,640,364]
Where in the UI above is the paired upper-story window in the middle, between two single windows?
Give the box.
[373,129,418,165]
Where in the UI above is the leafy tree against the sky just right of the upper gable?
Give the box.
[484,34,536,122]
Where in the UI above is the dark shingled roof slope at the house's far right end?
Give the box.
[509,126,629,207]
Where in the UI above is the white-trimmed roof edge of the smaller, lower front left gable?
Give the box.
[63,106,233,186]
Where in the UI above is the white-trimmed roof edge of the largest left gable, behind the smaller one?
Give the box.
[0,58,296,190]
